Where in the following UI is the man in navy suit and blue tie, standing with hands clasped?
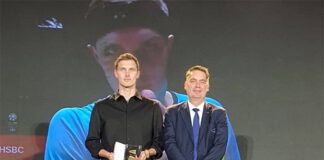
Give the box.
[164,65,228,160]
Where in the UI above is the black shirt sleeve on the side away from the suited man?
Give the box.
[85,106,103,158]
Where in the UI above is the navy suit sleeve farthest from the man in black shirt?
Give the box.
[204,110,228,160]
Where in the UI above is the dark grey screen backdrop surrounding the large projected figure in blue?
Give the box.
[0,0,324,160]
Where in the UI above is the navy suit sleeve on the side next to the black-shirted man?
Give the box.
[163,110,186,160]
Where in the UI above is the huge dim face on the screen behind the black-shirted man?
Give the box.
[95,28,170,92]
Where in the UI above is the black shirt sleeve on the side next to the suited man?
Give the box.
[151,103,163,159]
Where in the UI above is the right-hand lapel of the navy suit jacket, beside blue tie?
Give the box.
[198,103,211,142]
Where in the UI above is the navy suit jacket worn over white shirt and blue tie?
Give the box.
[163,102,228,160]
